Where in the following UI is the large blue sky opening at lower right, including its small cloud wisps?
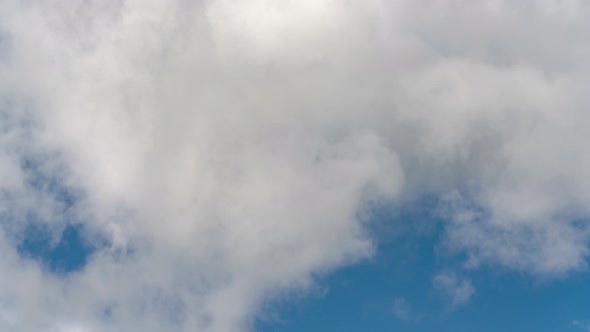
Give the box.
[257,197,590,332]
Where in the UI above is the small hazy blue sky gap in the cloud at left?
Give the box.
[2,150,104,274]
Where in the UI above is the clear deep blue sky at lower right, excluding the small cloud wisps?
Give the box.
[261,220,590,332]
